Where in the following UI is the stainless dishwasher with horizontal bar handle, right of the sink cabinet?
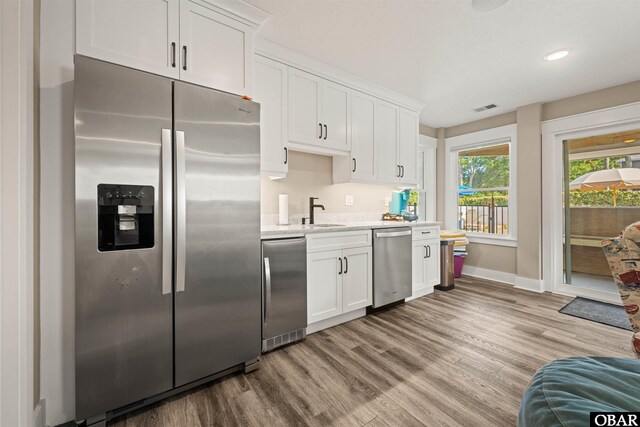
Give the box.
[372,227,411,308]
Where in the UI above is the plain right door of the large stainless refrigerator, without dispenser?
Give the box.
[174,82,261,387]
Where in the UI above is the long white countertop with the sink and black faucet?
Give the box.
[261,221,440,239]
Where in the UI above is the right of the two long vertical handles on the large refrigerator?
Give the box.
[176,131,187,292]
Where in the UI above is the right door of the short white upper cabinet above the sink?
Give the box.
[320,80,351,151]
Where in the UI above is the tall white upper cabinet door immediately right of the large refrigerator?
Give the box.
[254,55,289,178]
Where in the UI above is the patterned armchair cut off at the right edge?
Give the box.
[602,222,640,356]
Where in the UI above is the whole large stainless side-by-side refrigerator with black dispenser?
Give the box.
[75,56,261,420]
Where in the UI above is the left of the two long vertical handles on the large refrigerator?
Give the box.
[161,129,173,295]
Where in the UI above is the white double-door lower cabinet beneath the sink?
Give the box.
[307,230,373,330]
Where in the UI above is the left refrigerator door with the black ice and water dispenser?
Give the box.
[75,56,173,420]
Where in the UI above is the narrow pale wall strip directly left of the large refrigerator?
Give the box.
[40,0,75,425]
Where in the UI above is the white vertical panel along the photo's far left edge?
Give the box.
[0,0,35,426]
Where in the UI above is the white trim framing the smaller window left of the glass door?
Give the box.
[444,124,518,247]
